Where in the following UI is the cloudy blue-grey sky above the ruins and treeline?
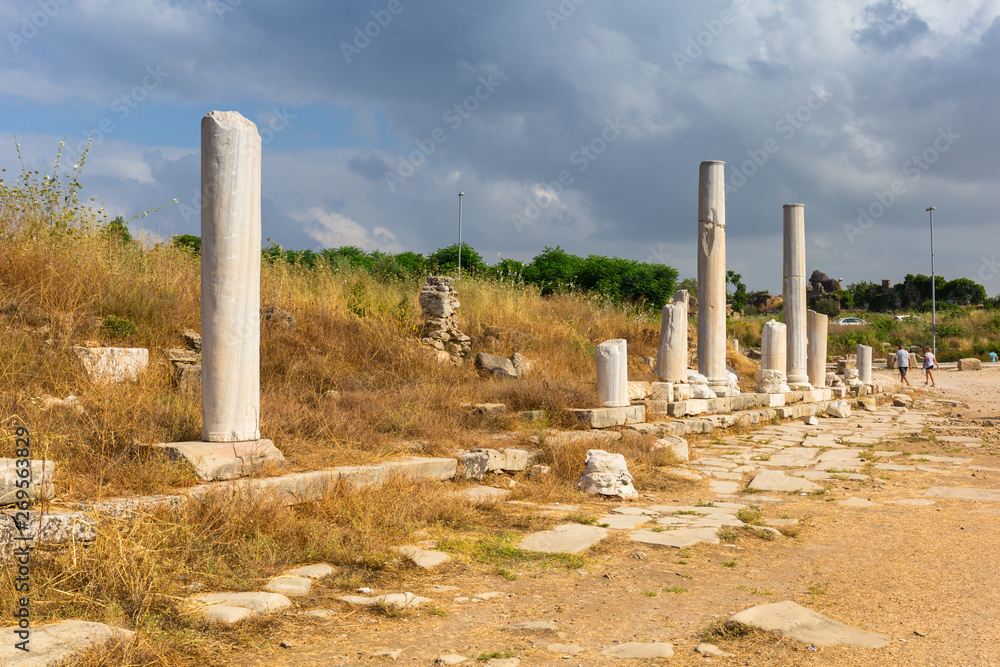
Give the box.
[0,0,1000,295]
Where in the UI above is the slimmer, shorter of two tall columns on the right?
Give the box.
[782,204,812,391]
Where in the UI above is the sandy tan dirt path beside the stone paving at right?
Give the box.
[225,368,1000,666]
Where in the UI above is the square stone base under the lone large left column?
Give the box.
[153,439,285,481]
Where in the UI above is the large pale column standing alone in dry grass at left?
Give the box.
[201,111,261,442]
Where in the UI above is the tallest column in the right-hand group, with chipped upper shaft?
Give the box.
[698,161,729,396]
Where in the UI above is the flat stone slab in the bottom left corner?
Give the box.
[0,621,135,667]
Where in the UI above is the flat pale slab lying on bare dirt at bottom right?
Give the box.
[730,600,890,648]
